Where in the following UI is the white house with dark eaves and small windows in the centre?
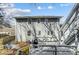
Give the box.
[15,16,61,42]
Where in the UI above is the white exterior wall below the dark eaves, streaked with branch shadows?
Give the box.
[16,19,59,42]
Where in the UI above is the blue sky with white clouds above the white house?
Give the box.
[0,3,74,23]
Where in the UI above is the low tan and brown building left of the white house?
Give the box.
[0,27,15,49]
